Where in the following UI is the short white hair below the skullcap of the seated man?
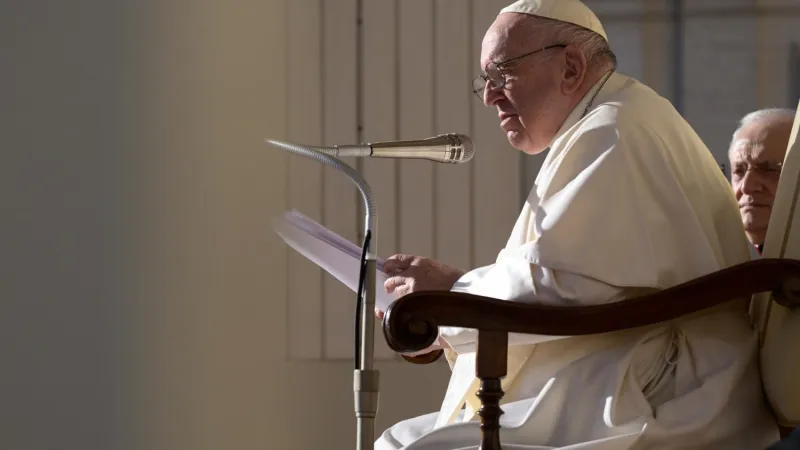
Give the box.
[531,16,617,70]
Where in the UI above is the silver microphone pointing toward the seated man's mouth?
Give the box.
[316,134,475,164]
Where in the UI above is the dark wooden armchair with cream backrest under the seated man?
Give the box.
[383,103,800,450]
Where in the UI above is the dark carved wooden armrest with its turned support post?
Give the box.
[383,259,800,450]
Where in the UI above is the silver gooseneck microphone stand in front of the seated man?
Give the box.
[266,139,380,450]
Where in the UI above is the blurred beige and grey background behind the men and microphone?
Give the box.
[0,0,800,450]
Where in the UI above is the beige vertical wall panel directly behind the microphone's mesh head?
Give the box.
[434,0,478,270]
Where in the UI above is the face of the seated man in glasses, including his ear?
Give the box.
[480,14,586,154]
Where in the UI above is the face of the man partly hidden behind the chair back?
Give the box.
[729,121,792,245]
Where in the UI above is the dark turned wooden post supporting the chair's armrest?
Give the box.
[475,331,508,450]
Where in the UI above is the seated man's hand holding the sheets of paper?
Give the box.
[383,255,464,298]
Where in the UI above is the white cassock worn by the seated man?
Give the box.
[376,73,778,450]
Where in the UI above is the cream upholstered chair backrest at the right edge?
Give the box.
[751,100,800,427]
